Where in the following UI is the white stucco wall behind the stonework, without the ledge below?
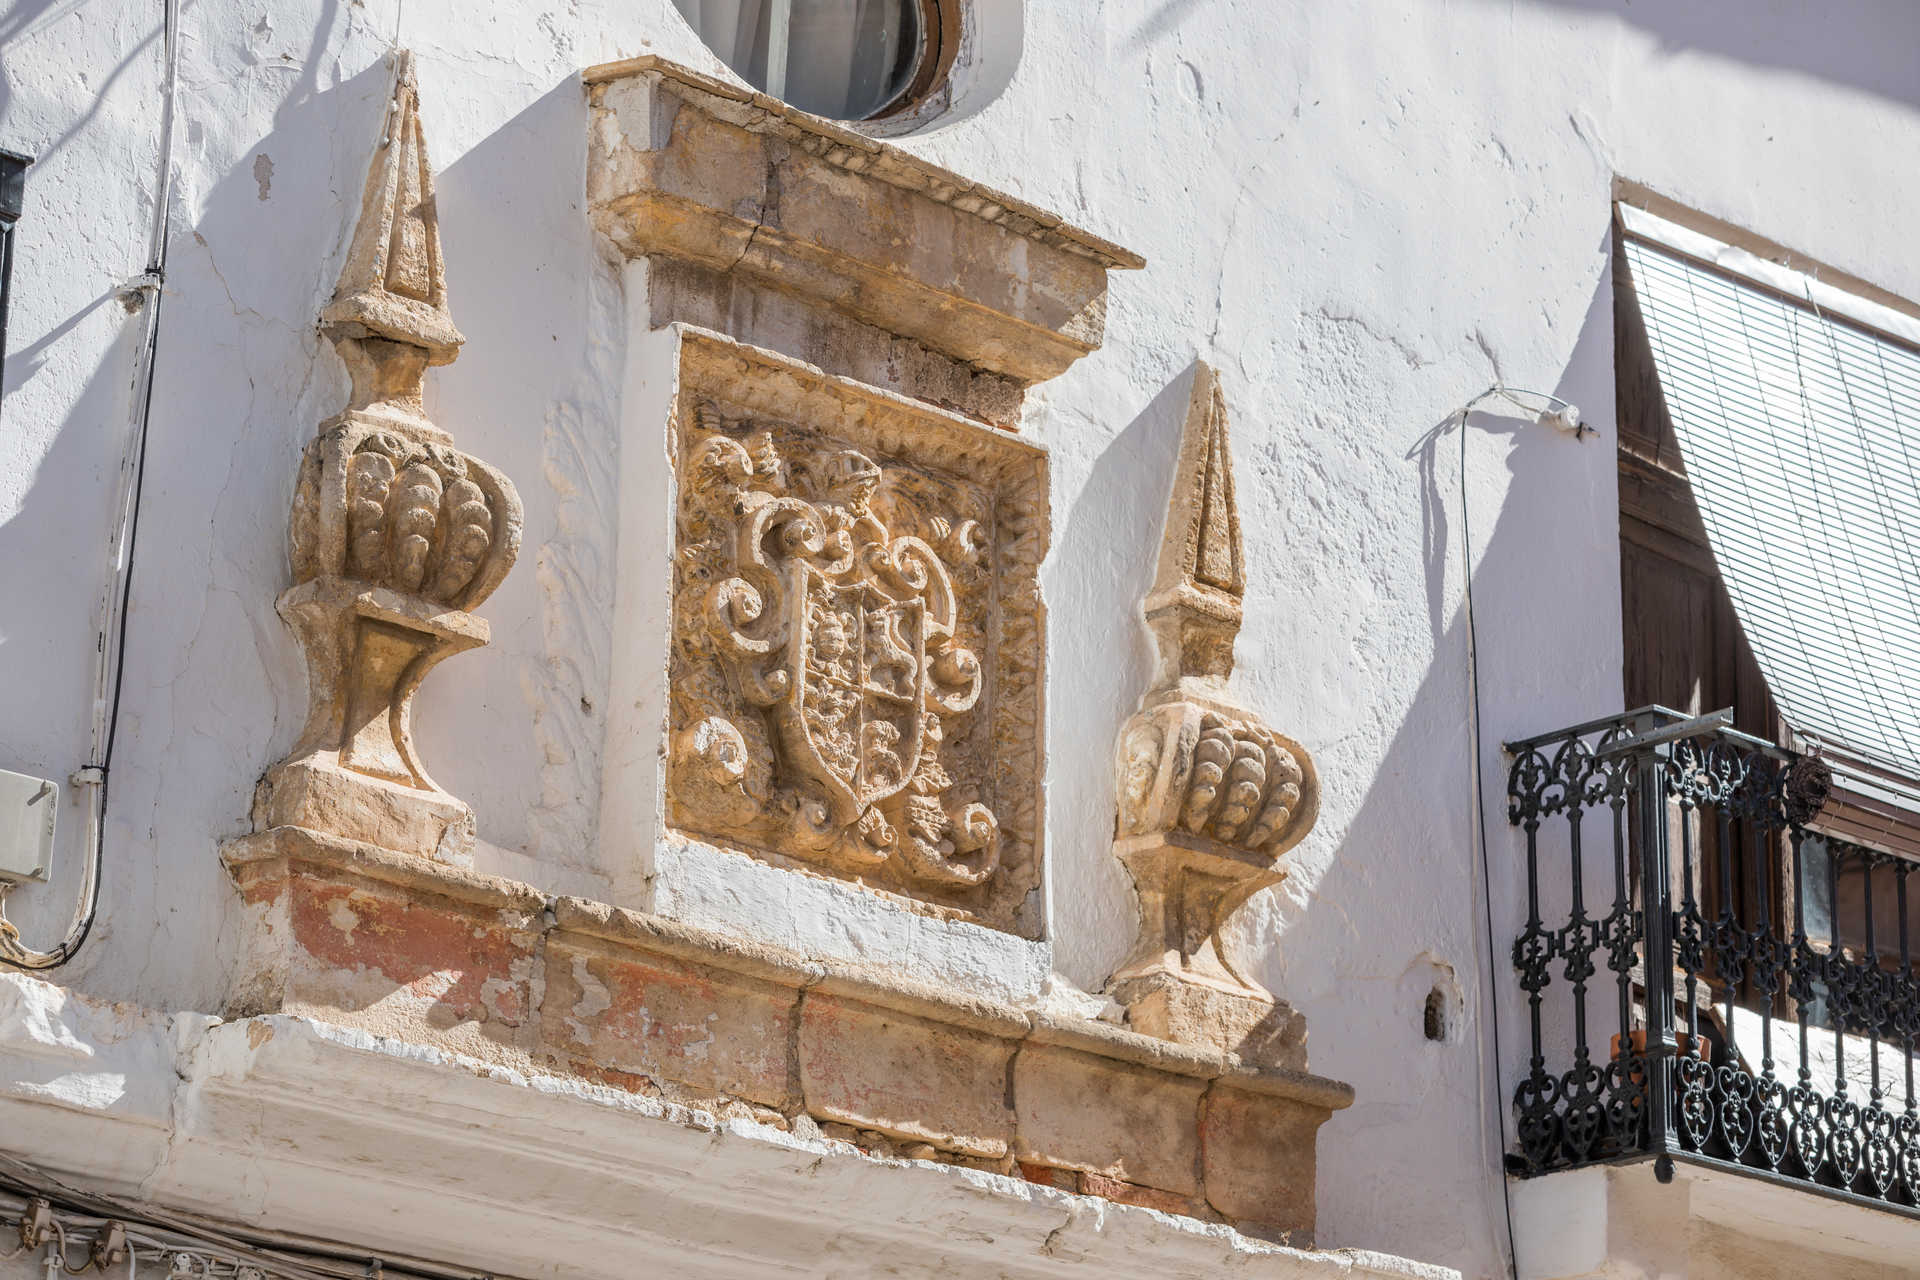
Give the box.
[0,0,1920,1274]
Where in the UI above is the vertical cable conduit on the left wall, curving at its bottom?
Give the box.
[0,0,180,971]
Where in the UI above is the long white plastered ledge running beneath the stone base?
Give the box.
[0,975,1459,1280]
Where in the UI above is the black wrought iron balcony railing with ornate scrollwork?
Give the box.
[1507,708,1920,1213]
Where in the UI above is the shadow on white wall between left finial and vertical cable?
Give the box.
[30,47,390,1007]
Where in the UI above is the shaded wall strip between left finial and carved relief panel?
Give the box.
[426,65,626,898]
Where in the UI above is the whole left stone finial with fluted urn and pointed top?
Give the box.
[253,54,520,860]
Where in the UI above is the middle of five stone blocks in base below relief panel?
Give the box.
[799,990,1016,1157]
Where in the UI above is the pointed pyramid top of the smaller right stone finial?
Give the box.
[1146,363,1246,689]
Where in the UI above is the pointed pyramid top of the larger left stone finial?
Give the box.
[321,50,465,416]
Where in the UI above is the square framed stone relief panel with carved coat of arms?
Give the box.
[666,332,1046,936]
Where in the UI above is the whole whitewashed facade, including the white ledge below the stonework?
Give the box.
[0,0,1920,1276]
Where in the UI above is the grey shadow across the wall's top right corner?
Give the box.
[1534,0,1920,106]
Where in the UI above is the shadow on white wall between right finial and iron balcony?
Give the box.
[1229,255,1620,1272]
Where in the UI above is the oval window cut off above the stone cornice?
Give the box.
[674,0,958,121]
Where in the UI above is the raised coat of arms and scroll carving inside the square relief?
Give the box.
[672,411,1002,887]
